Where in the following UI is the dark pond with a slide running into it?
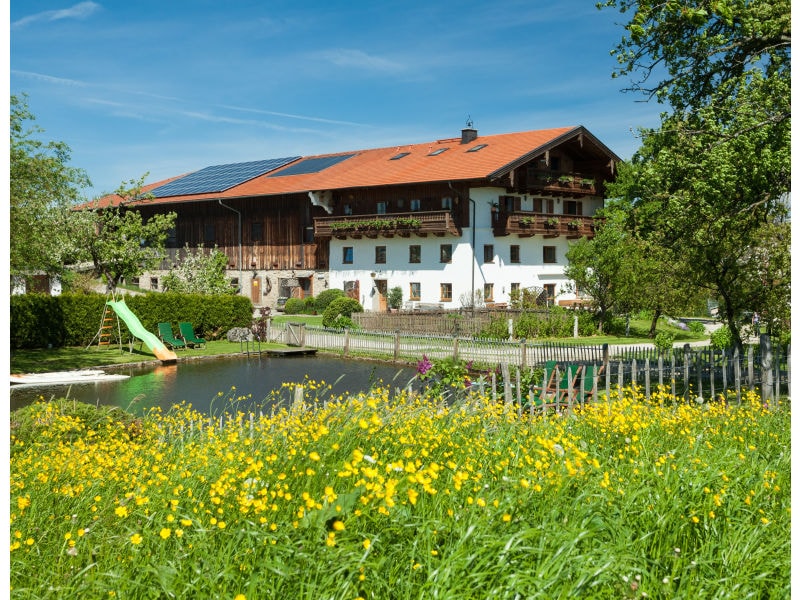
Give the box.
[11,355,415,414]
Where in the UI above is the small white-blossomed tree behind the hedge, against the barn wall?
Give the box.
[161,244,236,295]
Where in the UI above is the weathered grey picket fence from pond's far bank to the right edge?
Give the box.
[255,323,791,402]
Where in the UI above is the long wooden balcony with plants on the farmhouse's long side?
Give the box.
[314,210,461,240]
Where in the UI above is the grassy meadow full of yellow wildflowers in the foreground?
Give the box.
[10,381,791,600]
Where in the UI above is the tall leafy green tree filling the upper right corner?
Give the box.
[605,0,791,346]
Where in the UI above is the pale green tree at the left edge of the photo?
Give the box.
[9,95,91,286]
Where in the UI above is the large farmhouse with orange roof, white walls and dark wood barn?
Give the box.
[104,125,620,311]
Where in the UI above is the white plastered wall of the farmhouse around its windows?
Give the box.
[330,188,602,310]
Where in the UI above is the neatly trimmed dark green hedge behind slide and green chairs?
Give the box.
[10,293,253,350]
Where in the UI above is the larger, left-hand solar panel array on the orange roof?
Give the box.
[151,156,300,198]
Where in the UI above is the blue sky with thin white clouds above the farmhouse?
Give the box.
[9,0,663,198]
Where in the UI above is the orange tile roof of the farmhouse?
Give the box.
[101,126,619,204]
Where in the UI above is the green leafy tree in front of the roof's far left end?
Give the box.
[76,176,176,292]
